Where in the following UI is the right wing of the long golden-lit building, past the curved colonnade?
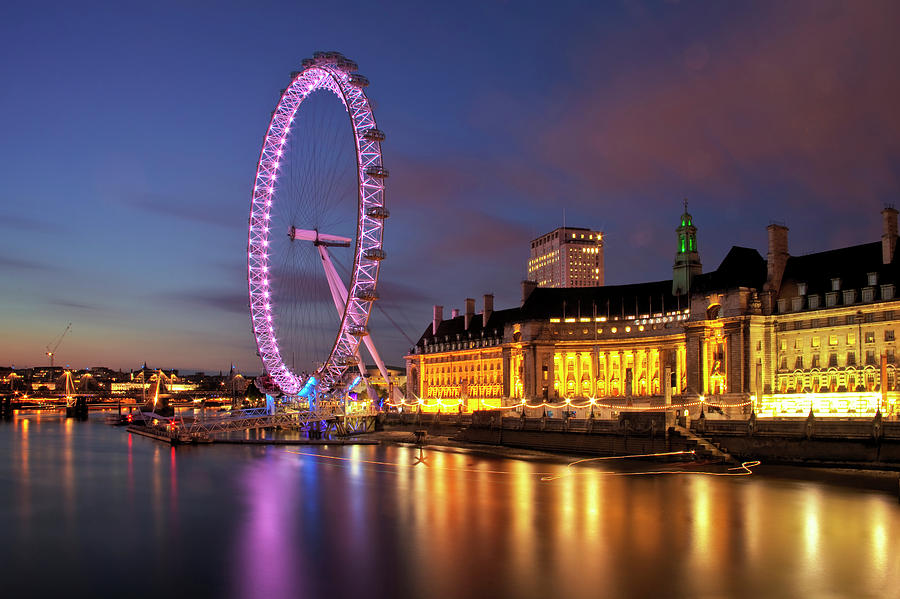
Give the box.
[757,207,900,416]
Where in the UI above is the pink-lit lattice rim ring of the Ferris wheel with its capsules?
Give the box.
[247,52,388,395]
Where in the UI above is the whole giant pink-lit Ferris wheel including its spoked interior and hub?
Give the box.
[247,52,388,396]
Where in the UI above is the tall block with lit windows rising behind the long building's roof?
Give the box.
[528,227,603,287]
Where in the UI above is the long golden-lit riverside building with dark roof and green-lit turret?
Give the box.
[406,208,900,417]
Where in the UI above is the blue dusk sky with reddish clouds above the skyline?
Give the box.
[0,0,900,373]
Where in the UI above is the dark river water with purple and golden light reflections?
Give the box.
[0,413,900,598]
